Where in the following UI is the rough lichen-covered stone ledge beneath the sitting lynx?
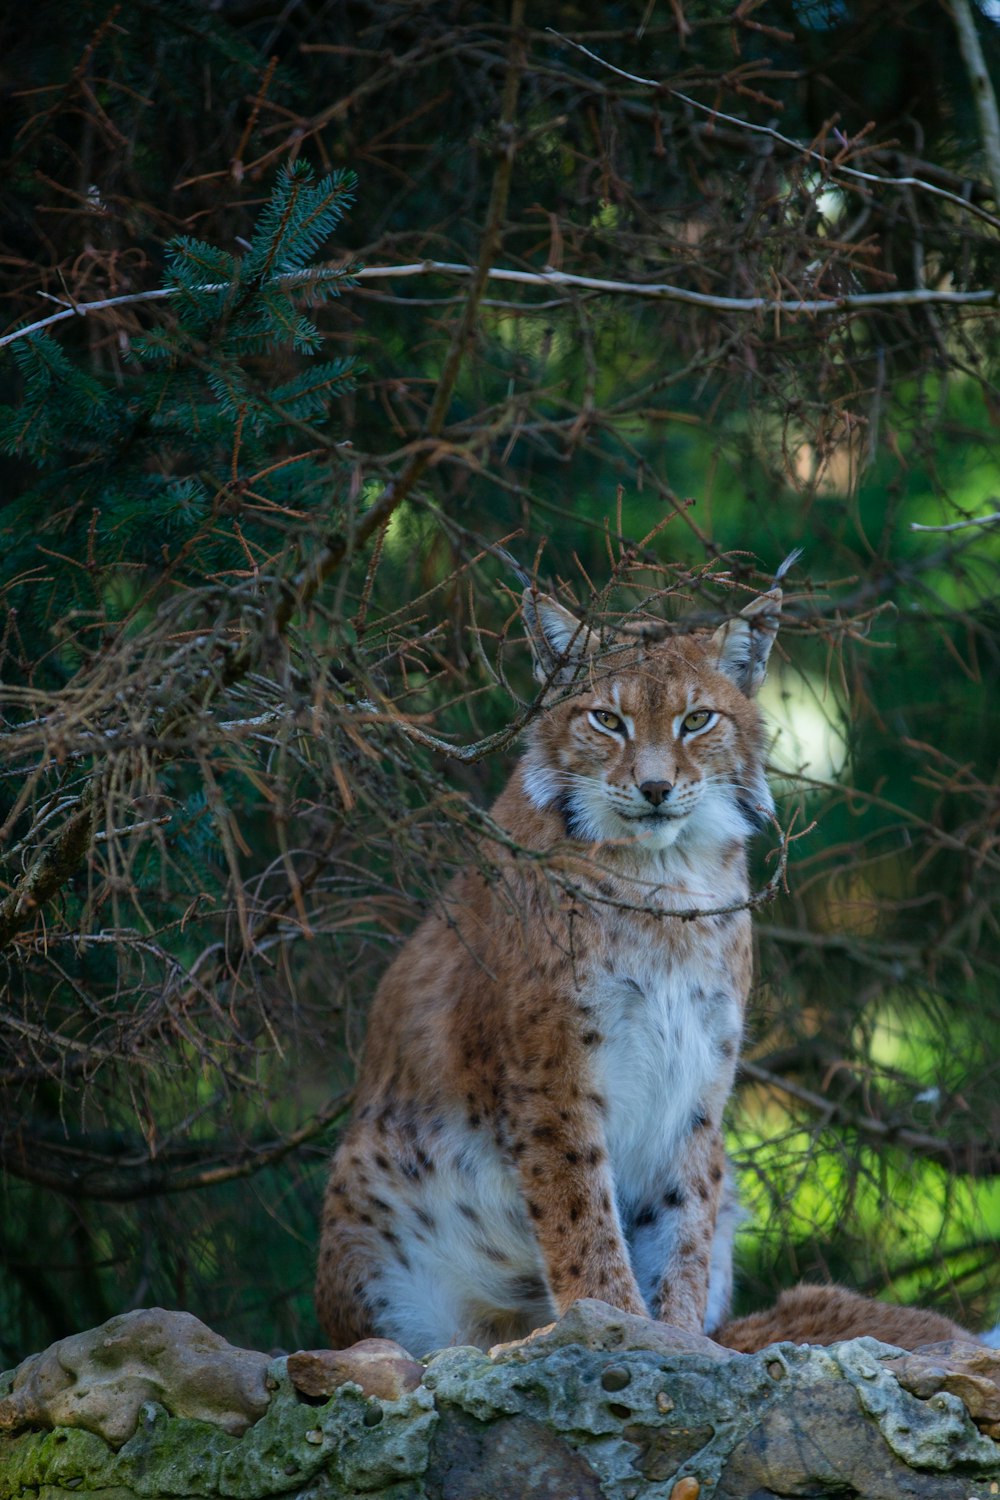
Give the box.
[0,1302,1000,1500]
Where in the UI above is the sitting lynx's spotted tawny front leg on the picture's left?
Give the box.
[511,1100,649,1317]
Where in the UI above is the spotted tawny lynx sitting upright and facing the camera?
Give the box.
[316,573,792,1353]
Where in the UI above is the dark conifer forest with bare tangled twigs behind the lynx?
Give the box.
[0,0,1000,1367]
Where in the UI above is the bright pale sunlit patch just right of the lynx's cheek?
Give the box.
[760,657,847,782]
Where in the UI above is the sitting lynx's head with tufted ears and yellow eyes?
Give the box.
[522,587,781,851]
